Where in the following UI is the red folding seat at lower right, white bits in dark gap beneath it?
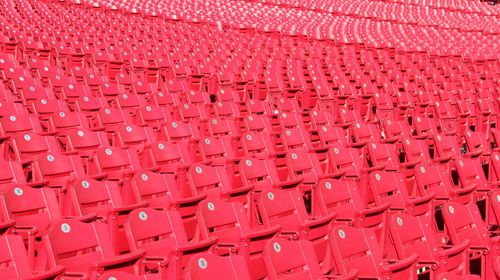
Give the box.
[388,213,470,279]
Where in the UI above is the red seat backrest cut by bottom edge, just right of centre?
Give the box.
[264,238,321,280]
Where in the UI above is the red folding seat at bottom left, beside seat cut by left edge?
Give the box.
[42,219,146,279]
